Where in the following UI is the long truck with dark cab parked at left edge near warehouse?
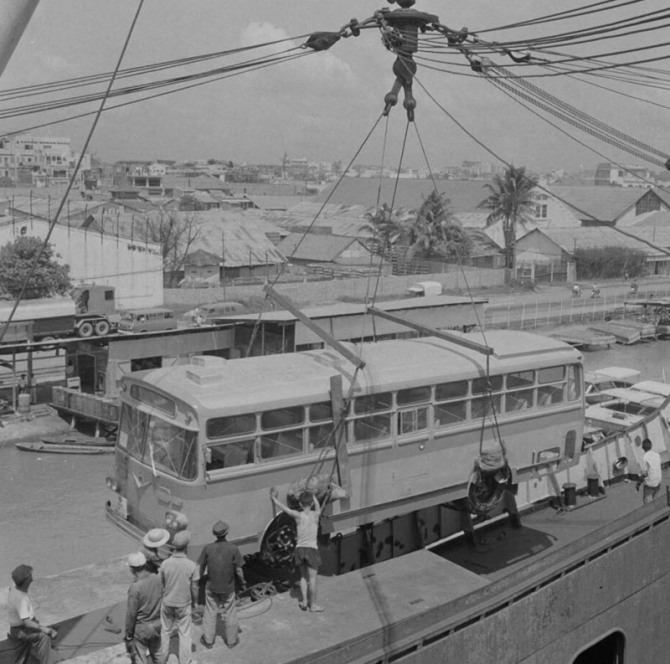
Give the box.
[0,284,116,343]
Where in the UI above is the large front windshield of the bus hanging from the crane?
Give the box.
[118,404,198,480]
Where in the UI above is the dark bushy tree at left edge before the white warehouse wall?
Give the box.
[0,236,72,300]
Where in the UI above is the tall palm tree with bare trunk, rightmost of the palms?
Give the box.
[486,166,537,273]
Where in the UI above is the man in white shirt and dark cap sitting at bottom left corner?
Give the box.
[7,565,58,664]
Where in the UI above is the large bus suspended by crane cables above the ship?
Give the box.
[106,330,584,569]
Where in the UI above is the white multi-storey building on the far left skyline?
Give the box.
[0,134,91,187]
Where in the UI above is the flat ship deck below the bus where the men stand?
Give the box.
[0,470,670,664]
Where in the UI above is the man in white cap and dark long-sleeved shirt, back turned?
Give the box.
[123,551,163,664]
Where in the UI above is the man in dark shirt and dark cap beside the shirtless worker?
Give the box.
[198,521,246,648]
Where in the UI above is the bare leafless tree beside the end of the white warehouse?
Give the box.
[146,210,202,286]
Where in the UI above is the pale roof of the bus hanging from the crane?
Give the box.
[131,331,582,415]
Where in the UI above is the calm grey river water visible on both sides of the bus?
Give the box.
[0,341,670,587]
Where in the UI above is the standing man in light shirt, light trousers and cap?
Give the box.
[158,530,198,664]
